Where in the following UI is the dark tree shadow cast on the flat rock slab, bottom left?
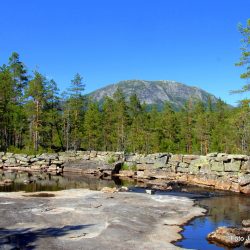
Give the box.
[0,224,93,249]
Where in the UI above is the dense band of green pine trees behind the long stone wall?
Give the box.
[0,52,250,154]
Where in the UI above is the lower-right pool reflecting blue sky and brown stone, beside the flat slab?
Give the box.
[176,195,250,250]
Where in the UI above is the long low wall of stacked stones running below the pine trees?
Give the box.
[0,151,250,194]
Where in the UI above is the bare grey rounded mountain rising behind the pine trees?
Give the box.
[89,80,221,109]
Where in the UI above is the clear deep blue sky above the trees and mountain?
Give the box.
[0,0,250,104]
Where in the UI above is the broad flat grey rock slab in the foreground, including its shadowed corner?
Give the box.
[0,189,205,250]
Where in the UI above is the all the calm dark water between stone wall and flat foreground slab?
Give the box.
[0,172,250,250]
